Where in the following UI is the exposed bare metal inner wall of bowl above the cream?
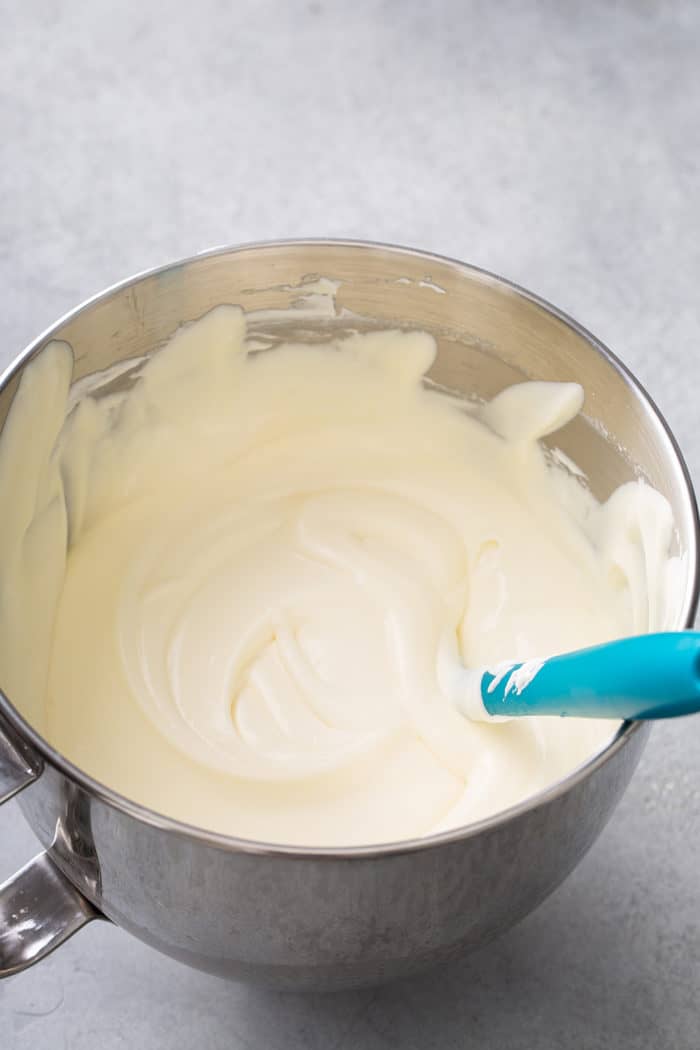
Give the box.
[13,242,695,537]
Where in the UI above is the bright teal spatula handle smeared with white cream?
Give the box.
[481,631,700,719]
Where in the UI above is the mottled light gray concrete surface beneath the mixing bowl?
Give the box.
[0,0,700,1050]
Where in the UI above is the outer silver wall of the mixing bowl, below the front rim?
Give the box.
[20,727,648,991]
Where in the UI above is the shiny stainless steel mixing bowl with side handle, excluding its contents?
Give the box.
[0,242,698,989]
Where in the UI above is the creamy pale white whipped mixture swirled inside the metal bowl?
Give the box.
[0,307,679,845]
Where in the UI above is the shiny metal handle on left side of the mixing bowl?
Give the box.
[0,717,104,978]
